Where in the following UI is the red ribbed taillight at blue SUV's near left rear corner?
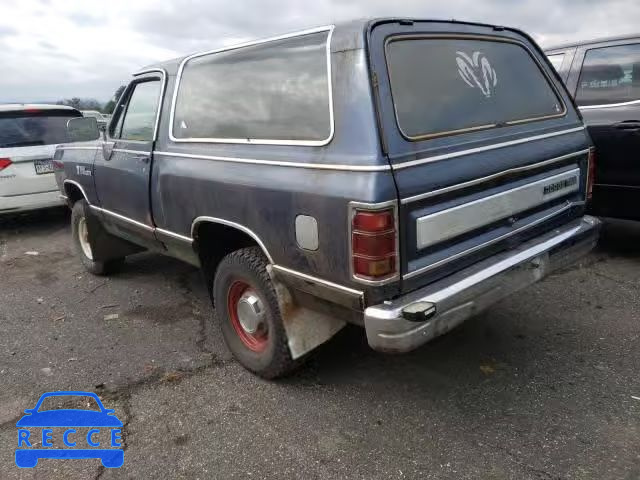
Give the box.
[351,208,398,281]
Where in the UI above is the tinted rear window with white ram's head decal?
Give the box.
[387,38,564,139]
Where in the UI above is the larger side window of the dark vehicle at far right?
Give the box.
[576,43,640,106]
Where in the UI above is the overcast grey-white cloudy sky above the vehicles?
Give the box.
[0,0,640,102]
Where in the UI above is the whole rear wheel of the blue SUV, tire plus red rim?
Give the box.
[213,247,298,379]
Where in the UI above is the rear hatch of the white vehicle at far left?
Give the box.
[0,108,80,197]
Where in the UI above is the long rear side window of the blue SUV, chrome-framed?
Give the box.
[173,32,331,143]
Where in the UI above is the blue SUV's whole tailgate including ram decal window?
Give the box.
[368,20,590,292]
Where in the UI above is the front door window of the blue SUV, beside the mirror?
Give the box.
[116,80,160,142]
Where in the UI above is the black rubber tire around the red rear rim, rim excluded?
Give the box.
[213,247,300,379]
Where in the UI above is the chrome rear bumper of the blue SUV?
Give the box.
[364,216,600,353]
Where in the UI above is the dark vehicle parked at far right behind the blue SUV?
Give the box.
[546,35,640,220]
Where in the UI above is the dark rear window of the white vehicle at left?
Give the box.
[0,112,78,148]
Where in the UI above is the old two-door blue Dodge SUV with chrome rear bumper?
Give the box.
[56,19,598,378]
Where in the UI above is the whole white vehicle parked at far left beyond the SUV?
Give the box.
[0,104,81,215]
